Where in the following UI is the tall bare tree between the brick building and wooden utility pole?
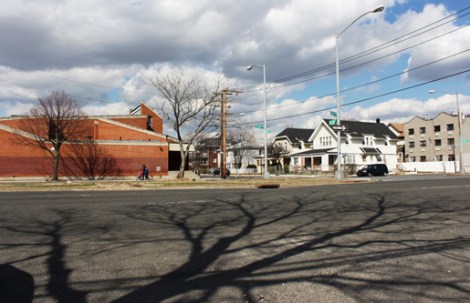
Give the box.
[152,74,222,178]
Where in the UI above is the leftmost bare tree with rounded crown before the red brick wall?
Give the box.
[19,91,87,181]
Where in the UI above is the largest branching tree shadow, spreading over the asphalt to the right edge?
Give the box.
[108,190,470,303]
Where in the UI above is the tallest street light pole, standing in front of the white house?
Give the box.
[335,6,384,180]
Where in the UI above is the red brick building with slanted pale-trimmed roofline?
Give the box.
[0,104,178,178]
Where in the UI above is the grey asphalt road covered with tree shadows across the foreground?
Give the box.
[0,176,470,303]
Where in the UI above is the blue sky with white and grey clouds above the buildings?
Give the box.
[0,0,470,138]
